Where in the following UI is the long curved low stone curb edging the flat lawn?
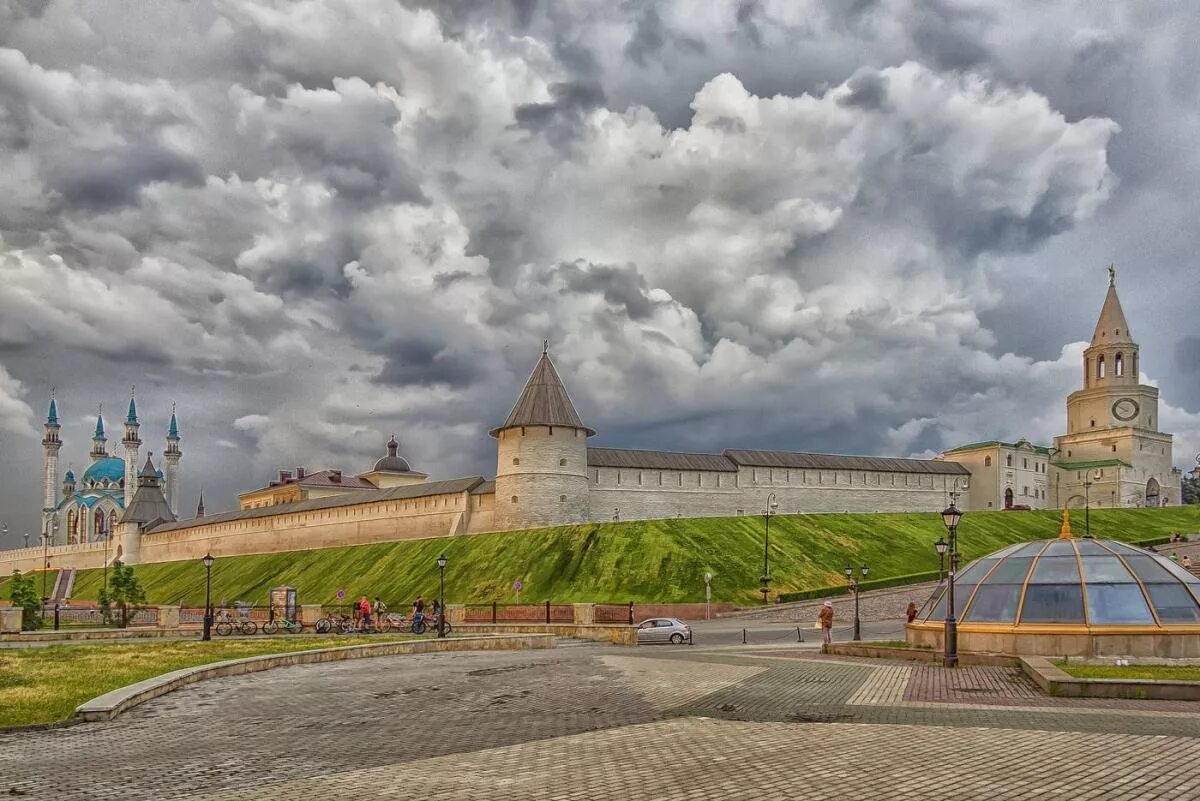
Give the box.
[66,634,554,730]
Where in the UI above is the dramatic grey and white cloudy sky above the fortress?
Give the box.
[0,0,1200,544]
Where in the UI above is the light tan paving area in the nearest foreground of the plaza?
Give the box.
[180,718,1200,801]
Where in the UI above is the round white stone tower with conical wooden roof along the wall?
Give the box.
[491,343,595,530]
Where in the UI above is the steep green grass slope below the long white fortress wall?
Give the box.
[56,506,1200,606]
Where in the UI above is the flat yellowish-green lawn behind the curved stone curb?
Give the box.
[0,637,403,727]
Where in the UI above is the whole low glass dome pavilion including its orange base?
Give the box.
[907,537,1200,657]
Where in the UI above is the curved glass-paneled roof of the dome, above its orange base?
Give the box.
[922,538,1200,627]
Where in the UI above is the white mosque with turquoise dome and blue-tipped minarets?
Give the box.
[42,392,184,546]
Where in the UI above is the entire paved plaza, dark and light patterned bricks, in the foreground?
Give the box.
[0,645,1200,801]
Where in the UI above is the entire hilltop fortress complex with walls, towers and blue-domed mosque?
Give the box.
[0,267,1182,570]
